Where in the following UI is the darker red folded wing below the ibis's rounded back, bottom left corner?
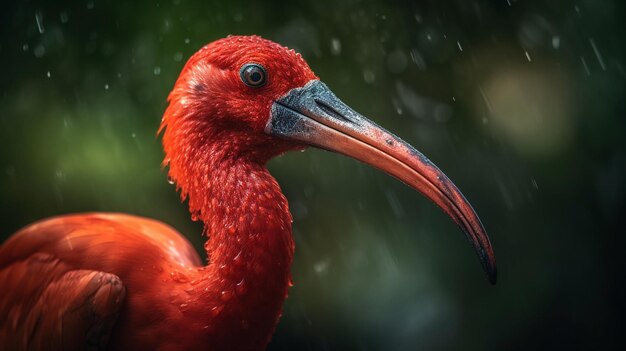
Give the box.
[0,253,126,350]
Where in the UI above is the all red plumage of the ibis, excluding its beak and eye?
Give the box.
[0,36,316,350]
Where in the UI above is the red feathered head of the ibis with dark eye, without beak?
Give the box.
[161,36,317,162]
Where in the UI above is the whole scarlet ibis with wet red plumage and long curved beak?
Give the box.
[0,36,496,350]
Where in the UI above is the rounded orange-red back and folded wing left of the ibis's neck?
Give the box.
[0,213,202,350]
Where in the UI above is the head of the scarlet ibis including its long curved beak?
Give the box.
[161,36,496,283]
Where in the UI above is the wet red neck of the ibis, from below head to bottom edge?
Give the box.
[178,136,294,349]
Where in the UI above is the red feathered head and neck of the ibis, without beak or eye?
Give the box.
[161,37,316,349]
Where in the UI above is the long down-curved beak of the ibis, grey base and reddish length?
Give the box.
[265,80,497,284]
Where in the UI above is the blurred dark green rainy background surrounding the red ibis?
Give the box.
[0,0,626,350]
